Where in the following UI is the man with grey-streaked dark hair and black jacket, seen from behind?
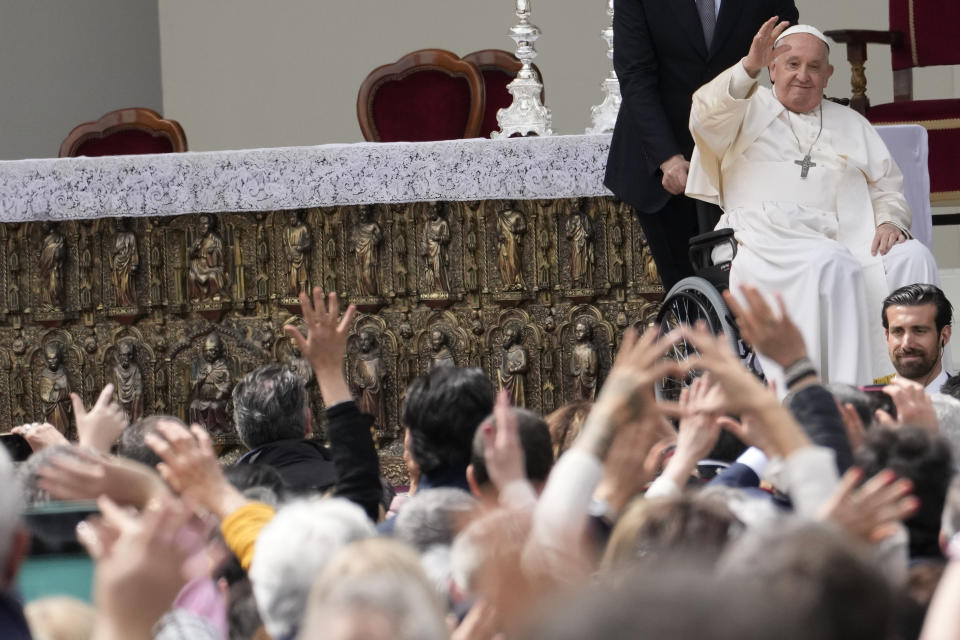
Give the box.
[233,363,337,493]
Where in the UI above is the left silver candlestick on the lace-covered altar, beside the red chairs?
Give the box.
[490,0,553,138]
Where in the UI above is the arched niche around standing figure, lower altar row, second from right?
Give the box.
[486,309,545,412]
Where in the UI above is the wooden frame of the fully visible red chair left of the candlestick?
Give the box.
[357,49,486,142]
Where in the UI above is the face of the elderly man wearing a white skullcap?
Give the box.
[770,33,833,113]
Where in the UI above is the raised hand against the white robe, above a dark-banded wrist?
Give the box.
[723,285,807,367]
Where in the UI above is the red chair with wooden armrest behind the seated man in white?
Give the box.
[826,0,960,202]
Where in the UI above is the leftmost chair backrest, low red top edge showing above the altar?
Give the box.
[60,107,187,158]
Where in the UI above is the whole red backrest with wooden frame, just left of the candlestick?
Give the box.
[357,49,485,142]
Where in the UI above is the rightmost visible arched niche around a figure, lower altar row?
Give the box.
[557,304,616,403]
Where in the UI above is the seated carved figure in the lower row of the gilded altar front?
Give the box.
[190,332,233,433]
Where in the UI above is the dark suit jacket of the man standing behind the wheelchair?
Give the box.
[604,0,798,213]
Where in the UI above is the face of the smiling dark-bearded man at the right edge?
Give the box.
[886,304,950,385]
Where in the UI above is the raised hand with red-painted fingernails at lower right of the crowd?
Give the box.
[818,467,920,544]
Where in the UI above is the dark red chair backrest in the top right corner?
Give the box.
[890,0,960,71]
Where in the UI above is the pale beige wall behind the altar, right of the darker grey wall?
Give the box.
[159,0,954,150]
